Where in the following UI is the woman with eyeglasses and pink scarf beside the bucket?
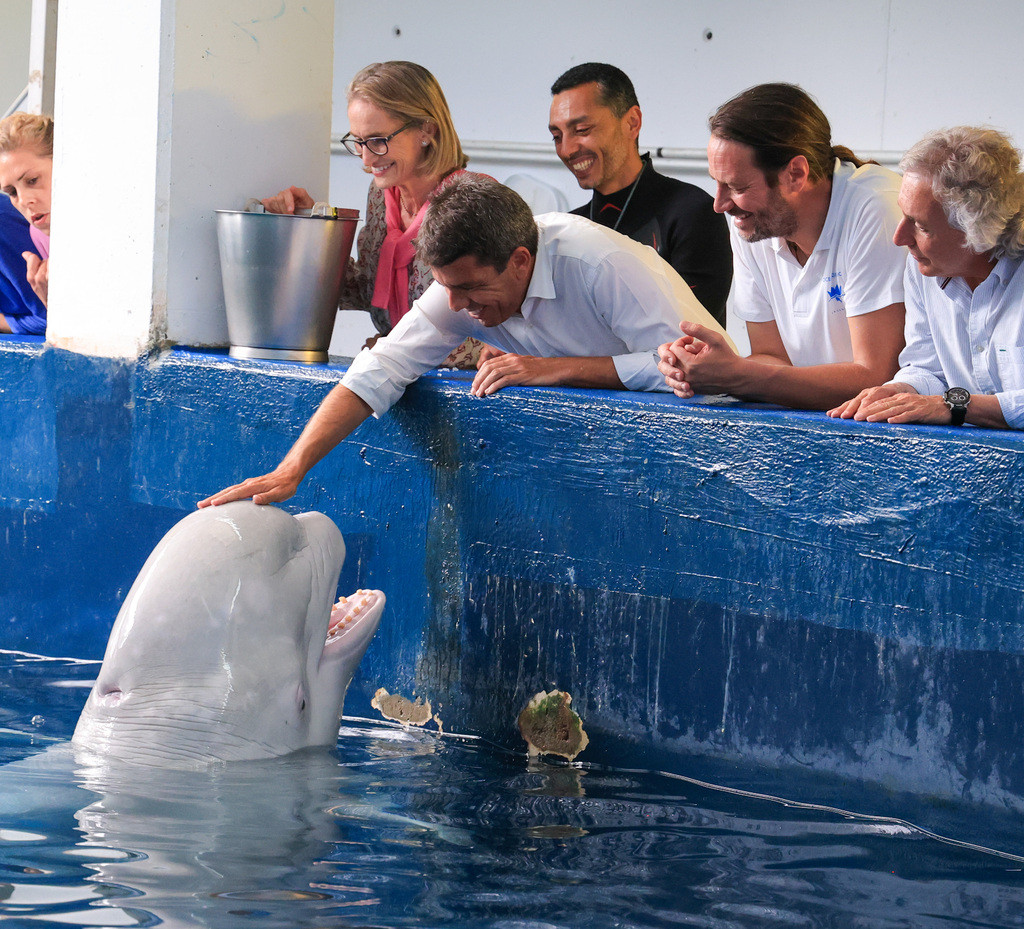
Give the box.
[263,61,487,368]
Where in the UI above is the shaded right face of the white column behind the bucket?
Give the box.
[164,0,334,345]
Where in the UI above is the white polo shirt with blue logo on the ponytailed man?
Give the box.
[729,159,906,367]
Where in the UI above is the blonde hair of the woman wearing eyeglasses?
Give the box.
[347,61,469,177]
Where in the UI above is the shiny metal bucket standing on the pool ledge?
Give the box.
[217,210,359,362]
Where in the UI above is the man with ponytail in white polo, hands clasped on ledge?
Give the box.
[660,84,905,410]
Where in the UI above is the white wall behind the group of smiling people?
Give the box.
[323,0,1024,352]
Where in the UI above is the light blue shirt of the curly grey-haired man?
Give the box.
[893,256,1024,429]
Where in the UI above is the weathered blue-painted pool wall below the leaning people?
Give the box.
[0,338,1024,808]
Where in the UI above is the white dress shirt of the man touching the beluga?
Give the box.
[342,213,731,416]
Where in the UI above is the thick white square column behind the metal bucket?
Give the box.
[47,0,334,357]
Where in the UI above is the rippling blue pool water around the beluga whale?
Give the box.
[0,652,1024,929]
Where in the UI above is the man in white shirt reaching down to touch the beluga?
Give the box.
[200,175,728,507]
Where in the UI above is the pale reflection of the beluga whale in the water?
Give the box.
[76,751,373,927]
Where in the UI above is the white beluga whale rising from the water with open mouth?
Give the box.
[73,501,384,767]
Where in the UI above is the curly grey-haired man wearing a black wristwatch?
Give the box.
[829,126,1024,429]
